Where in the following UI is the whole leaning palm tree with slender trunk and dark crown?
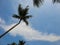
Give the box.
[0,4,32,38]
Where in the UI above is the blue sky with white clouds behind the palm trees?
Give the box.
[0,0,60,45]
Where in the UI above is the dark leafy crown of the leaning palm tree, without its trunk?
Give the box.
[13,4,32,25]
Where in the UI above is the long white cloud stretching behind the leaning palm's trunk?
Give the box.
[0,17,60,42]
